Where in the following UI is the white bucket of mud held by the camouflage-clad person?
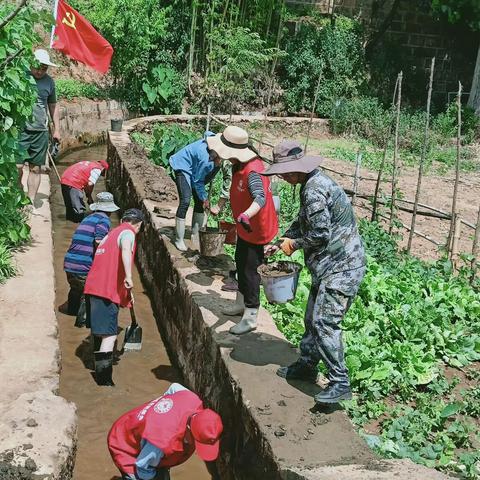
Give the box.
[257,261,303,303]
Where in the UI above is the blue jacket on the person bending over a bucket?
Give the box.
[168,132,220,201]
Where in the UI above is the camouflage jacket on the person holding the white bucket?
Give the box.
[284,170,365,283]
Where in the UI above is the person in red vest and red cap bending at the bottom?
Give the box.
[107,383,223,480]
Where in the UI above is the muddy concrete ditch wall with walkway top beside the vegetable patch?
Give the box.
[107,119,454,480]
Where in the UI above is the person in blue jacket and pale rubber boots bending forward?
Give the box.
[168,132,231,252]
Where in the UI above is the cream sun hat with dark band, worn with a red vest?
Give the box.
[205,126,258,163]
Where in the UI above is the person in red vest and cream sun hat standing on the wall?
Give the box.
[206,126,278,335]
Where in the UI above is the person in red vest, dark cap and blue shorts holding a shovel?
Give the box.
[84,208,144,387]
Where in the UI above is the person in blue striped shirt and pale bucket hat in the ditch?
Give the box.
[58,192,120,328]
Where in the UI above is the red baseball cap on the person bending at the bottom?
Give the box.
[190,408,223,462]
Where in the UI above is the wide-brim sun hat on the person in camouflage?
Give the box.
[261,140,323,176]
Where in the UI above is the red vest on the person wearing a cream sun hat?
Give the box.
[230,158,278,245]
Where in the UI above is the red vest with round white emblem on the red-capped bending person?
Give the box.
[108,390,203,473]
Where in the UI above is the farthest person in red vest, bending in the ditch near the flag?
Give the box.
[61,160,108,223]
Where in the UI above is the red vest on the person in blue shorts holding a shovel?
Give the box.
[84,223,136,307]
